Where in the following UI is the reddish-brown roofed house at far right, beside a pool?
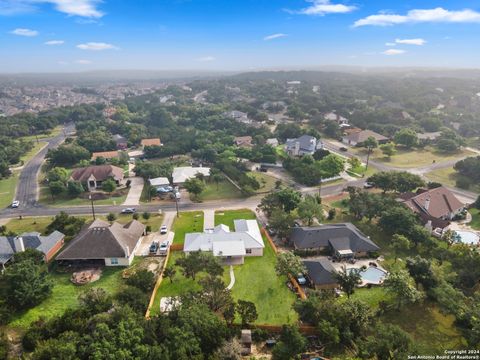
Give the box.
[398,186,465,235]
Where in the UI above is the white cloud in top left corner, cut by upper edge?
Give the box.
[0,0,104,18]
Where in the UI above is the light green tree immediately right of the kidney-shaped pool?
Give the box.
[384,270,424,309]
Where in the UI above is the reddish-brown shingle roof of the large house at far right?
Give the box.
[405,186,465,218]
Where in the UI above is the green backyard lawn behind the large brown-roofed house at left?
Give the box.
[9,267,125,329]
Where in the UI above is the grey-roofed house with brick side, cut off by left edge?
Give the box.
[0,231,65,267]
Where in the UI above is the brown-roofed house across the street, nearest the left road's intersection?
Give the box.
[71,165,123,191]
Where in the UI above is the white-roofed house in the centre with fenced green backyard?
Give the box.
[183,220,265,265]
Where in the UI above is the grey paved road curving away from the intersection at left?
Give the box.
[15,124,75,210]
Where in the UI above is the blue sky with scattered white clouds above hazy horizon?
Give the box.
[0,0,480,73]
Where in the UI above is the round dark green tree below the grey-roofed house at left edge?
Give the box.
[3,259,53,309]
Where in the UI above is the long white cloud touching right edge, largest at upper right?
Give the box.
[353,7,480,27]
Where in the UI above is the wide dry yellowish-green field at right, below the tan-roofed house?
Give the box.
[351,147,474,168]
